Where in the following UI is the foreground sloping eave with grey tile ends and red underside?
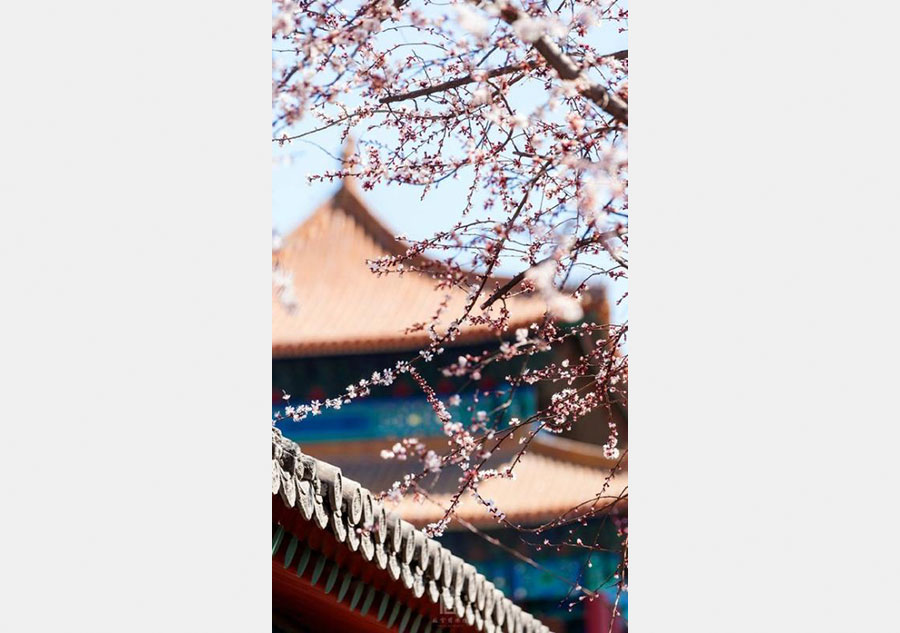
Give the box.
[272,428,550,633]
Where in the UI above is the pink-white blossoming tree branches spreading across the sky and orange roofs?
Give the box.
[272,0,629,599]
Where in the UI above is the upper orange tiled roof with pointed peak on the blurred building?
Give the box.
[272,179,546,357]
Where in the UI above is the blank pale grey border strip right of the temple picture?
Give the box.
[629,2,900,633]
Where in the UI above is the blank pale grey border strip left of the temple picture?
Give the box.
[0,1,271,633]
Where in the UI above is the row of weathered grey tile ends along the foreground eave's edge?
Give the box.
[272,427,550,633]
